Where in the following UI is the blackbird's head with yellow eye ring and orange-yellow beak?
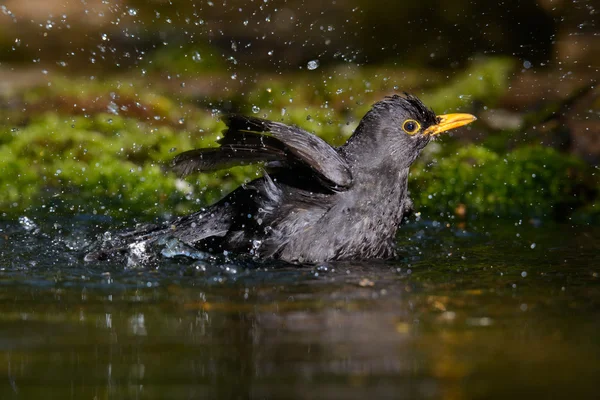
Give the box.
[344,94,477,170]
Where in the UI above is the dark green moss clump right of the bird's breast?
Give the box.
[411,145,592,217]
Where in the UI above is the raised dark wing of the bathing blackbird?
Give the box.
[171,115,352,189]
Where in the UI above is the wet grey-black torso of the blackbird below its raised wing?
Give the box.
[216,166,408,262]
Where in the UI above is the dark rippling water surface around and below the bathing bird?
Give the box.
[0,218,600,399]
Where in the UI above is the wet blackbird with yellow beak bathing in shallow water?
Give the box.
[86,94,476,263]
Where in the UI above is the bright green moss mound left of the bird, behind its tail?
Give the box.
[0,113,255,219]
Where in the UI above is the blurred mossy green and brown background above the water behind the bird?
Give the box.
[0,0,600,223]
